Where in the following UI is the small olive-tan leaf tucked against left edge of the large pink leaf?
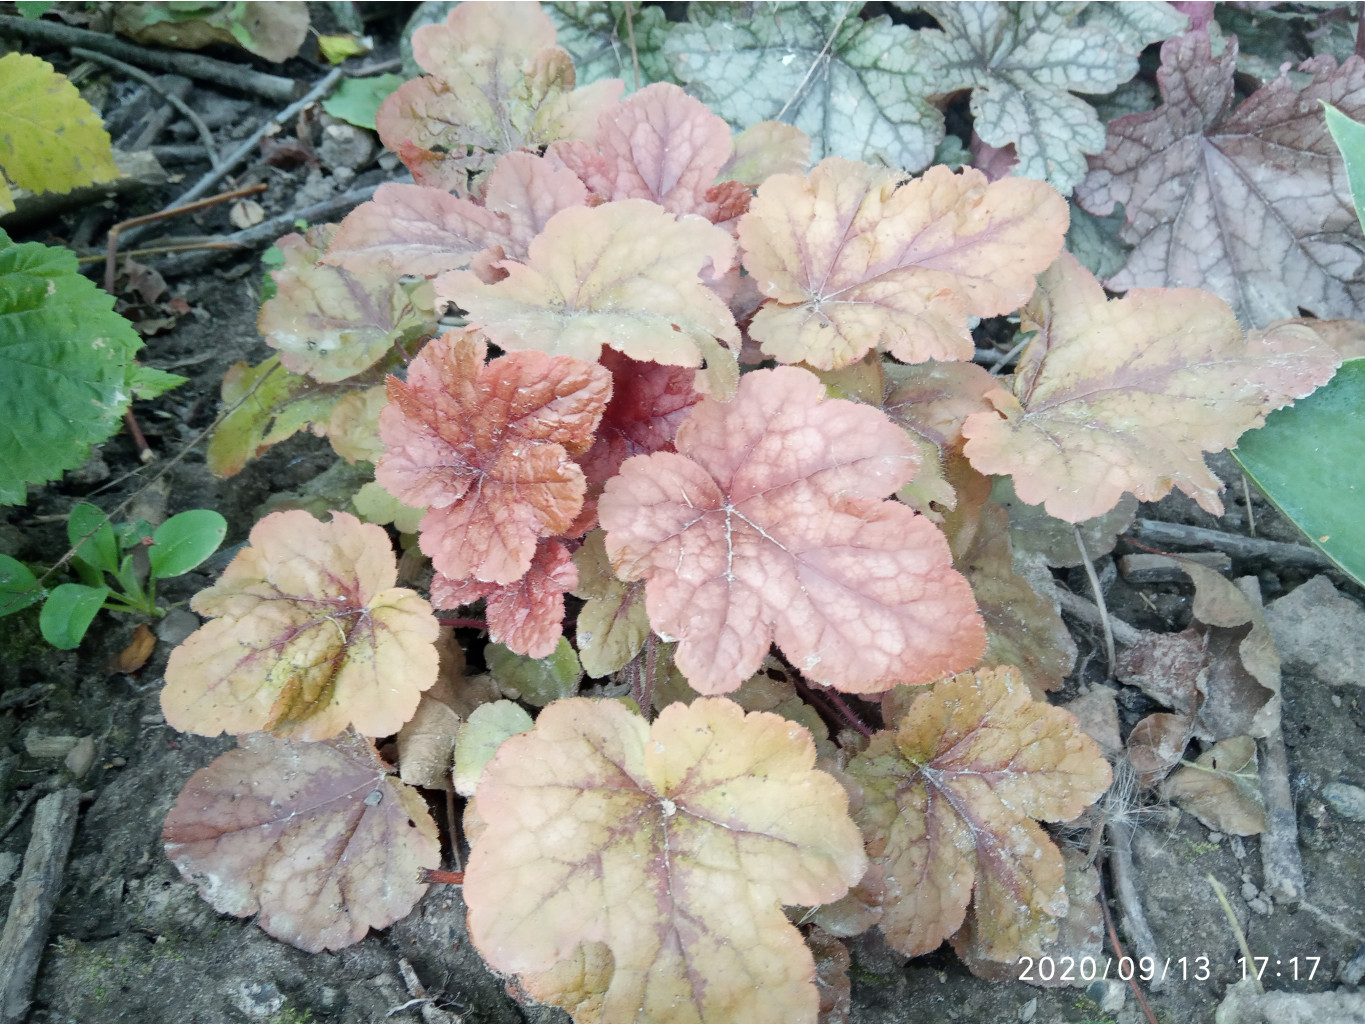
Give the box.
[573,530,650,677]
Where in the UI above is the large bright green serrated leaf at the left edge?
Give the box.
[0,230,166,504]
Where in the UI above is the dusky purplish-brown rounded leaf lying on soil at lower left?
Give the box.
[162,733,441,953]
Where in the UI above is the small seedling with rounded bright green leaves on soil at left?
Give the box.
[0,504,228,650]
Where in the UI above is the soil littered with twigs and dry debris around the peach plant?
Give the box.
[8,4,1365,1024]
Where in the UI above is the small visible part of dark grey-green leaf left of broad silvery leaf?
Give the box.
[543,0,674,91]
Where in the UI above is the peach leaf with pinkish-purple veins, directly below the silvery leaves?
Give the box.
[738,157,1069,370]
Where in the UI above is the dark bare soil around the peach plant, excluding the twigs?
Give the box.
[8,26,1365,1024]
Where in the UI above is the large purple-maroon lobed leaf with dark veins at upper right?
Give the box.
[1076,30,1365,328]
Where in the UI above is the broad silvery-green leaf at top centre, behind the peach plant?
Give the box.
[665,3,944,171]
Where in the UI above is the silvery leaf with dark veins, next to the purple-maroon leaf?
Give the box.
[910,3,1188,195]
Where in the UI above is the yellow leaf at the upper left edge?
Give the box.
[0,53,120,200]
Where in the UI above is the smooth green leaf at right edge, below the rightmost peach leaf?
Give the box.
[1233,359,1365,584]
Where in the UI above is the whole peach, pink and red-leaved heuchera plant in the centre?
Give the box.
[162,4,1338,1024]
